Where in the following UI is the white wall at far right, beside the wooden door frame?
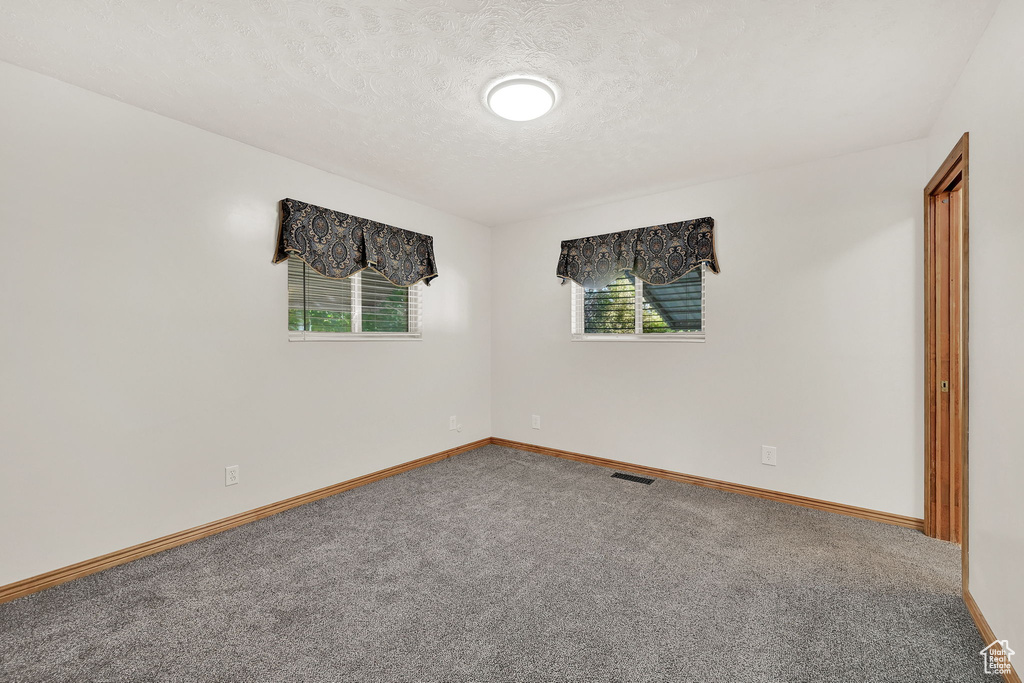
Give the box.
[929,0,1024,651]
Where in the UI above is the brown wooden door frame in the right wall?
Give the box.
[924,133,970,591]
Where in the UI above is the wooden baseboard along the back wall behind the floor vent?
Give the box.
[490,437,925,531]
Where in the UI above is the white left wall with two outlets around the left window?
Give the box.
[0,63,492,585]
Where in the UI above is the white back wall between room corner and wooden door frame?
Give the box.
[492,141,926,517]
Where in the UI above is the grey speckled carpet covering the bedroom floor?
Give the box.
[0,445,992,683]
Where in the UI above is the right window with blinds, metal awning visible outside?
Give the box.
[572,265,705,342]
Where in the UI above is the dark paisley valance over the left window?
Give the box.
[273,199,437,287]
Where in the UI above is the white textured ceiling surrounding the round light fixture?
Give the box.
[0,0,996,225]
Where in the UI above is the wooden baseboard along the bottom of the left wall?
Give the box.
[0,438,490,604]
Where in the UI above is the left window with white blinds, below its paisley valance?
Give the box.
[288,256,422,341]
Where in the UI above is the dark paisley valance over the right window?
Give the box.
[556,218,719,289]
